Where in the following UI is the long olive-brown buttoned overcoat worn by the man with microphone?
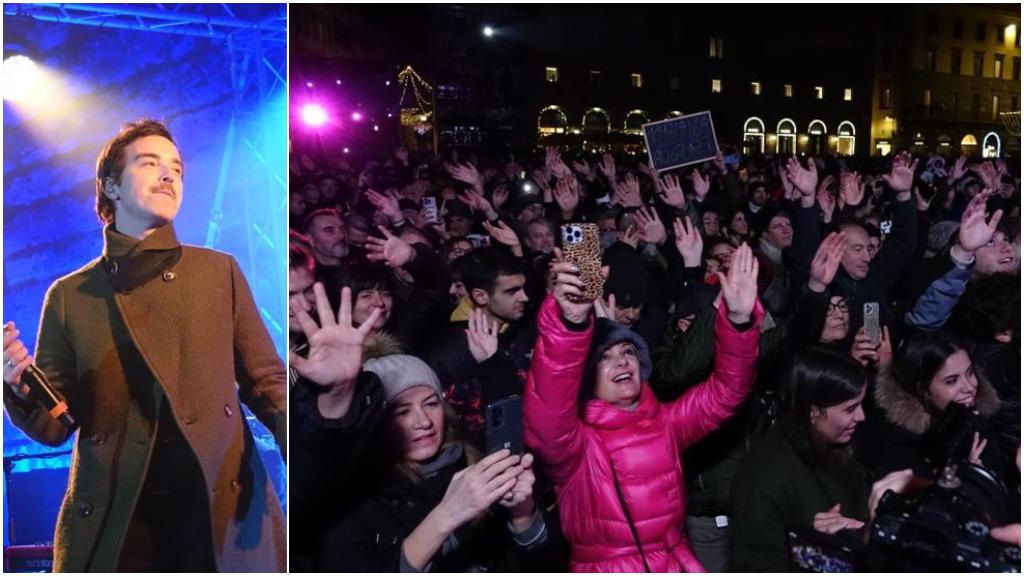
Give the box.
[3,224,287,572]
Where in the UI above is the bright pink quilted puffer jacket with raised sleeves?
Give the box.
[523,296,764,572]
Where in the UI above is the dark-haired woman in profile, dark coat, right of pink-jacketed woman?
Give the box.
[730,346,870,572]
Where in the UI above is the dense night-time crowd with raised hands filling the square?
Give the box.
[289,142,1021,572]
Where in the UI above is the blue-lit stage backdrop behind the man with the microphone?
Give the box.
[3,4,288,545]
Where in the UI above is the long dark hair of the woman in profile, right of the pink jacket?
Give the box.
[778,345,867,463]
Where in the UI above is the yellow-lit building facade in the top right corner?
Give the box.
[870,4,1021,157]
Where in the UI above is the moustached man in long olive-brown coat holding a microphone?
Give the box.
[3,120,287,572]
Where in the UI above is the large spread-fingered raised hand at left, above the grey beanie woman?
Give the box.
[288,282,381,386]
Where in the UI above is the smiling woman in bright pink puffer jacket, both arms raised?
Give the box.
[523,244,763,572]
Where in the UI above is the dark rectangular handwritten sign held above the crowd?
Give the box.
[643,111,718,171]
